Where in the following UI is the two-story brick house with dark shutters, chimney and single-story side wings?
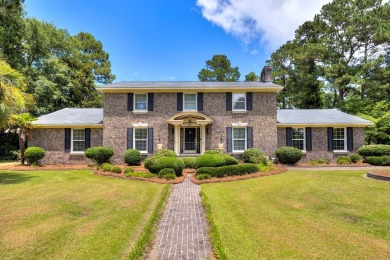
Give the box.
[29,66,371,164]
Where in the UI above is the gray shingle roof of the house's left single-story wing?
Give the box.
[34,108,103,126]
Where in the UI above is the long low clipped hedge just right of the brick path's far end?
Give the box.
[196,163,259,178]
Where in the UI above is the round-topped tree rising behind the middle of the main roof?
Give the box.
[198,54,241,81]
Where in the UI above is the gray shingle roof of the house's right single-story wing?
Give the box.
[277,109,372,125]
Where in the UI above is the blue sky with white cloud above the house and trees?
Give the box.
[25,0,329,82]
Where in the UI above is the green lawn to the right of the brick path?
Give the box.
[202,171,390,259]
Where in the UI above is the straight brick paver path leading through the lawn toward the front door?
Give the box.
[148,174,211,259]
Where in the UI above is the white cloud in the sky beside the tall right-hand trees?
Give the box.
[197,0,331,50]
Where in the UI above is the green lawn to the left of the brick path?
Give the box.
[0,170,165,259]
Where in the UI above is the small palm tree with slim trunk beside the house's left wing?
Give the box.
[8,113,37,165]
